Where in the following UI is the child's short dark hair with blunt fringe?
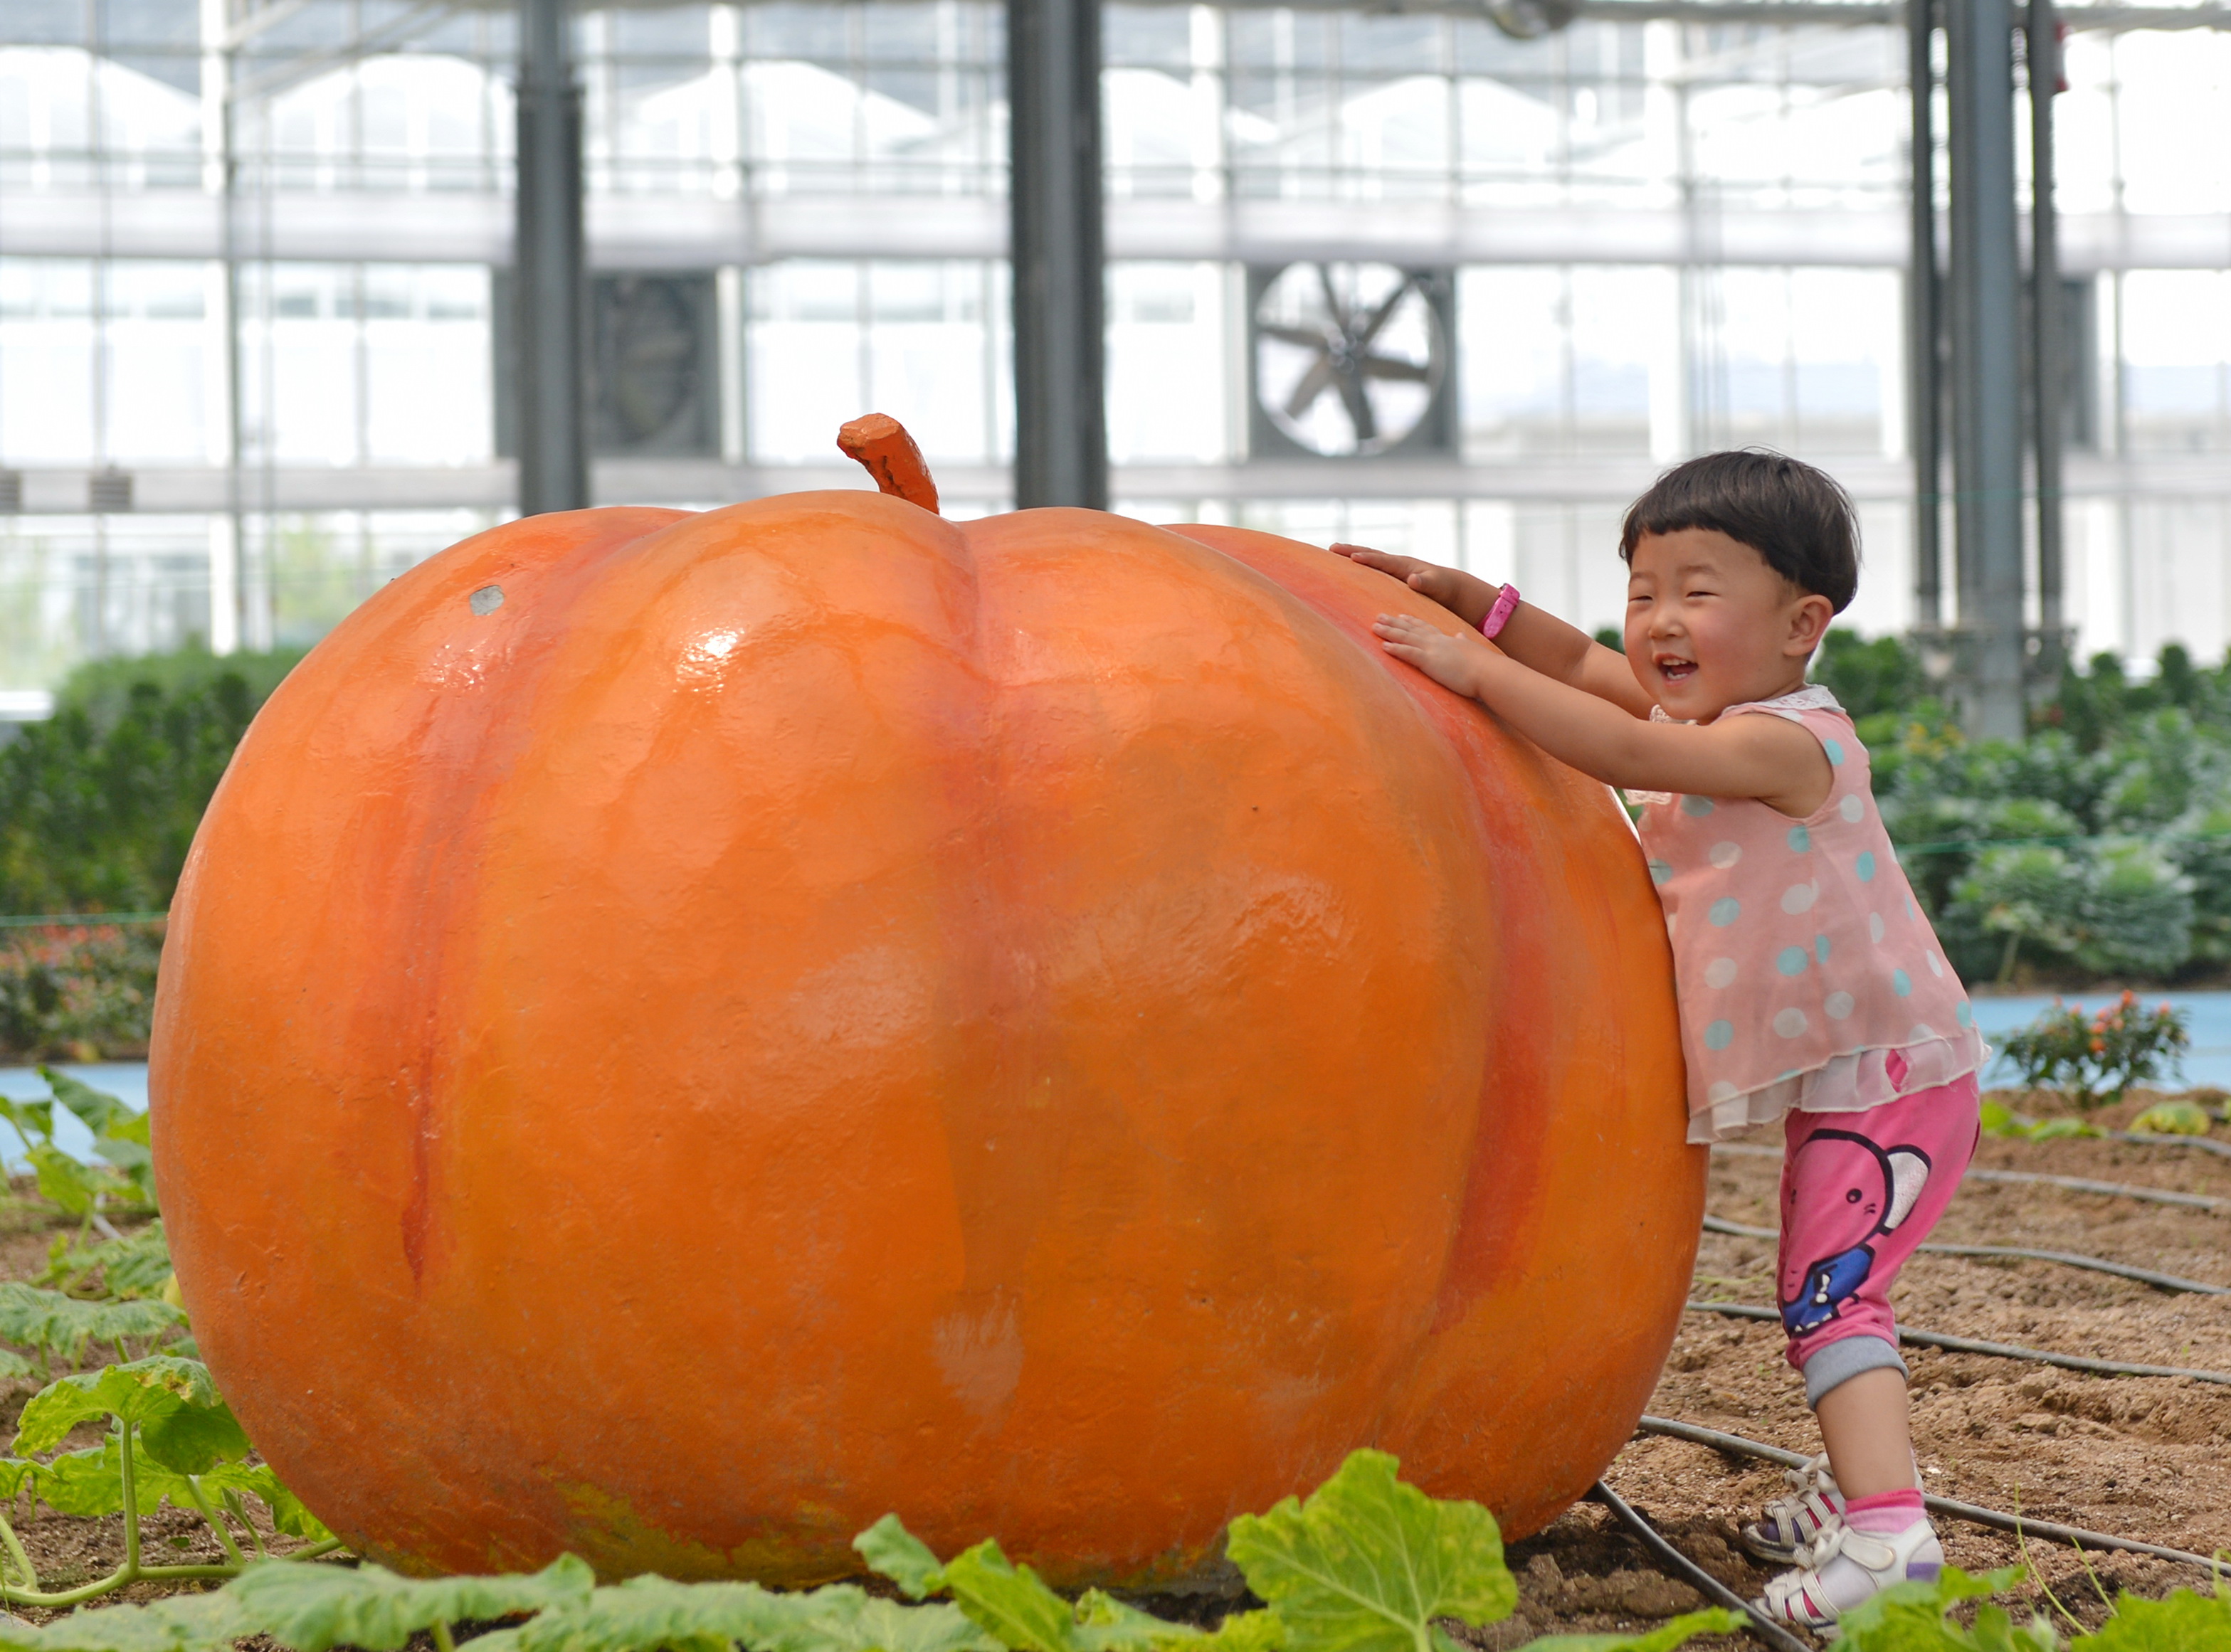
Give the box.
[1620,448,1858,613]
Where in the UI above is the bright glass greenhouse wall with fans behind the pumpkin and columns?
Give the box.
[0,0,2231,714]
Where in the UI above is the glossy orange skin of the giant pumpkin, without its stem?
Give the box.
[149,493,1702,1583]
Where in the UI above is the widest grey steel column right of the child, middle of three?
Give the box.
[1946,0,2026,740]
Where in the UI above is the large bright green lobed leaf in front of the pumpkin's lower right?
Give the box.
[1225,1451,1519,1652]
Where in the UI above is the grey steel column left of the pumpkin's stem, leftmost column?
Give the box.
[511,0,589,515]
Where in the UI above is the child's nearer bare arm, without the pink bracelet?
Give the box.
[1372,613,1834,818]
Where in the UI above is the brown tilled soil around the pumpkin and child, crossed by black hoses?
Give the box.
[0,1097,2231,1652]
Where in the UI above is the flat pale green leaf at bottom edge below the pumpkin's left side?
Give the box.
[226,1554,602,1652]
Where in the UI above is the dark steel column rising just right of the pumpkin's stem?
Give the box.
[1006,0,1109,511]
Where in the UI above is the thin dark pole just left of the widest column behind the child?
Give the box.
[1905,0,1946,631]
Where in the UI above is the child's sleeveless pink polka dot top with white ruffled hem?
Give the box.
[1631,687,1990,1141]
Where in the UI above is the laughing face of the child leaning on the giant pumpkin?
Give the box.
[1626,529,1834,722]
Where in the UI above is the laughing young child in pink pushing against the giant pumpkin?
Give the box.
[1334,452,1988,1630]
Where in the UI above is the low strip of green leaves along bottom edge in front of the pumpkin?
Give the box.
[0,1449,1740,1652]
